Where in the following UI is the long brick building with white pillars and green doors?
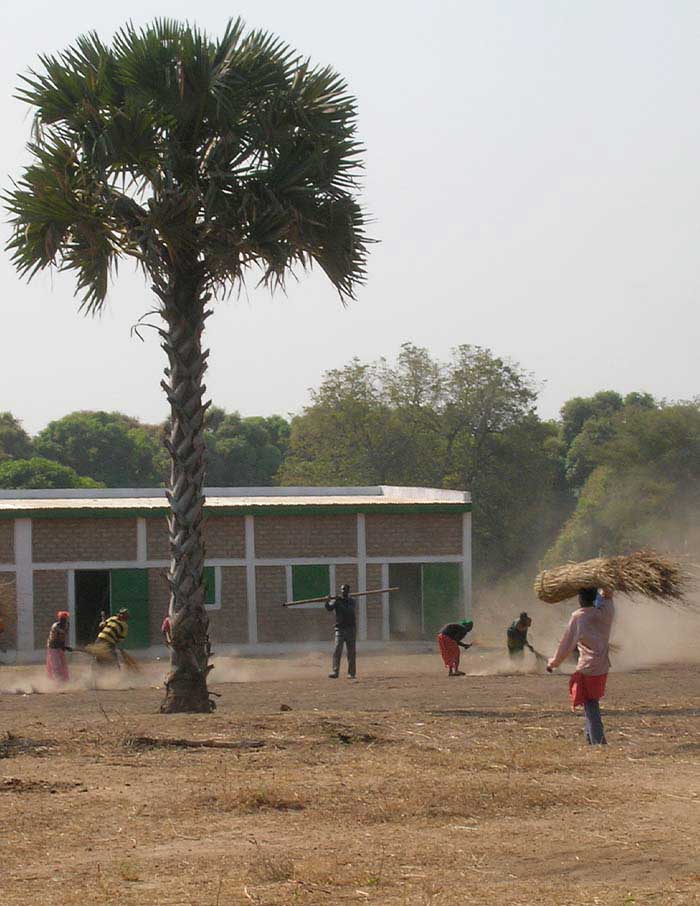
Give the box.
[0,487,471,660]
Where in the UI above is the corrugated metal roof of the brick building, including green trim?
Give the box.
[0,486,471,518]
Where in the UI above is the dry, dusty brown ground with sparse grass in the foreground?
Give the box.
[0,653,700,906]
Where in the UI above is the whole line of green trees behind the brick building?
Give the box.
[0,344,700,580]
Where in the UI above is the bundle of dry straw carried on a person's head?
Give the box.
[535,550,689,604]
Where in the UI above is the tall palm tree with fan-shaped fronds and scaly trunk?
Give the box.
[5,20,370,712]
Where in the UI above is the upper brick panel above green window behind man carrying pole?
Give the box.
[255,516,357,557]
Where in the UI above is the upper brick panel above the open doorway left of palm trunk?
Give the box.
[32,517,136,563]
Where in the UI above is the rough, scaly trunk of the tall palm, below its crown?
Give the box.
[156,273,214,713]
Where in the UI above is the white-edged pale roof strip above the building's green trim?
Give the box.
[0,485,471,503]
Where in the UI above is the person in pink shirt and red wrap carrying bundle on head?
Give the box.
[547,588,615,746]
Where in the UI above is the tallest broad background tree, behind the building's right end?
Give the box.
[279,344,570,578]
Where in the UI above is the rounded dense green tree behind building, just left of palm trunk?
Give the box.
[34,412,167,488]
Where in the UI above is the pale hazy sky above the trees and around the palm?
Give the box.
[0,0,700,432]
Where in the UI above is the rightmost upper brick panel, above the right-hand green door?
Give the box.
[365,513,462,557]
